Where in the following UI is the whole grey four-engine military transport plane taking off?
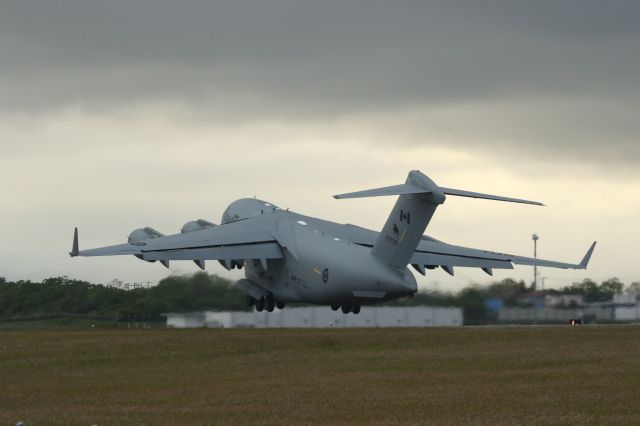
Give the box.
[70,171,596,314]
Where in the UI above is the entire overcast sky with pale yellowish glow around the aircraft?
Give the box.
[0,0,640,289]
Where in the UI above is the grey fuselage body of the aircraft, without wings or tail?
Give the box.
[222,199,418,306]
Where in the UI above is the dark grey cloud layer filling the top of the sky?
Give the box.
[0,0,640,160]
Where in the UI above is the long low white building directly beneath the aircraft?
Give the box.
[166,306,462,328]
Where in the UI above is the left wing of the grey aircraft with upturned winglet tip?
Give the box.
[69,217,283,264]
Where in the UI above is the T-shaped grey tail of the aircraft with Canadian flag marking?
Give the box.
[334,170,543,271]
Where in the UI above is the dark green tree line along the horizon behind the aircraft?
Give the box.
[0,272,640,322]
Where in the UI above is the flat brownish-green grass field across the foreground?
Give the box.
[0,326,640,426]
